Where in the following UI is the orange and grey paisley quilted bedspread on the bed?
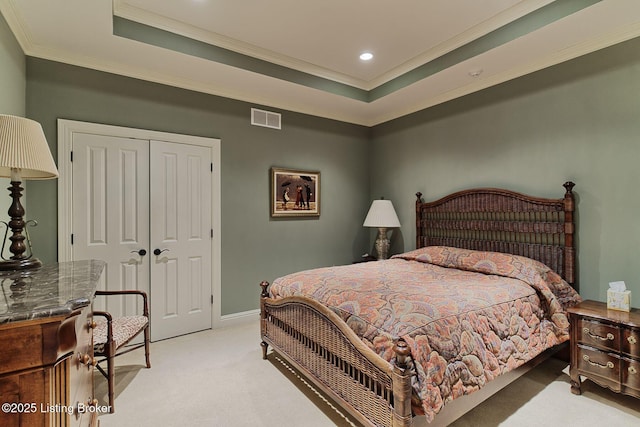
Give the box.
[270,246,580,421]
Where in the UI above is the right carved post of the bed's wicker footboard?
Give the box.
[393,338,412,427]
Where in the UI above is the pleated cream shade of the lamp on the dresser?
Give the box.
[0,114,58,179]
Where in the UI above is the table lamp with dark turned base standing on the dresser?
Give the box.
[0,114,58,270]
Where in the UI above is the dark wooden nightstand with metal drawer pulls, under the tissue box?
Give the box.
[567,301,640,398]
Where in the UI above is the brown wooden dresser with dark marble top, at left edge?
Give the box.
[0,260,108,427]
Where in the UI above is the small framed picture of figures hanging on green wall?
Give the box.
[271,167,320,217]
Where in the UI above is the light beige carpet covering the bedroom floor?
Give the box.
[95,320,640,427]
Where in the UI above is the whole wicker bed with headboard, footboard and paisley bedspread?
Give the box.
[260,182,580,427]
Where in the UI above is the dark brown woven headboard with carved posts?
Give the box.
[416,182,576,285]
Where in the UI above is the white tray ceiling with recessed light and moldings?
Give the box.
[0,0,640,126]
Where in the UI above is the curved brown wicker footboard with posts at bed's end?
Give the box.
[260,282,413,427]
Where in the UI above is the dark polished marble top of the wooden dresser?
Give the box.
[0,260,105,325]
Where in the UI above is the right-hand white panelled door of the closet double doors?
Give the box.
[150,141,212,341]
